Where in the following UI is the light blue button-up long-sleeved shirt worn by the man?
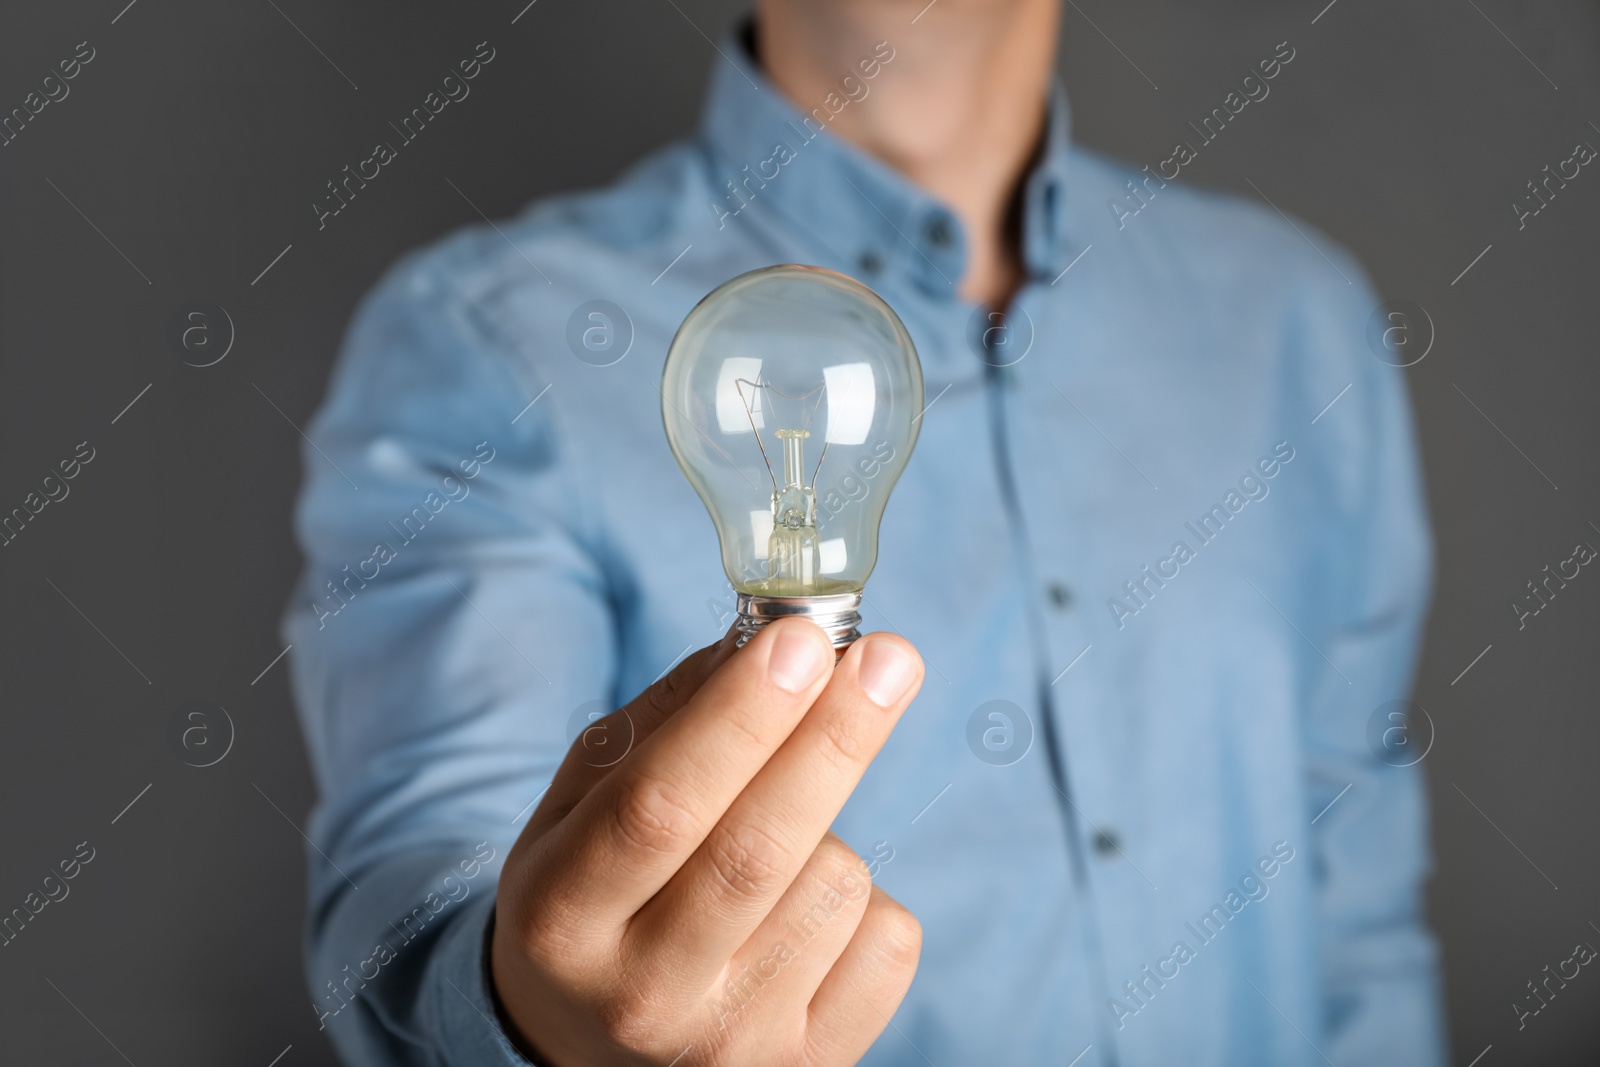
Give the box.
[285,31,1443,1067]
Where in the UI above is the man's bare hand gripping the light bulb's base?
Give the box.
[491,619,923,1067]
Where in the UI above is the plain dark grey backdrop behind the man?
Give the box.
[0,0,1600,1067]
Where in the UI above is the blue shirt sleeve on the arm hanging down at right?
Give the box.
[1304,267,1445,1067]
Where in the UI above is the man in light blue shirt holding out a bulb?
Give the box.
[286,0,1443,1067]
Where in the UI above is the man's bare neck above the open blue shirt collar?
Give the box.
[755,0,1059,307]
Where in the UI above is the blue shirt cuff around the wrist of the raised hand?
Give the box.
[430,894,541,1067]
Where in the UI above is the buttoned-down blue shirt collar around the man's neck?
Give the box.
[701,24,1070,301]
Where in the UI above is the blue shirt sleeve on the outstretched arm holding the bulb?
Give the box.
[283,246,614,1067]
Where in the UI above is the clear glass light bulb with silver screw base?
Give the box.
[661,264,922,648]
